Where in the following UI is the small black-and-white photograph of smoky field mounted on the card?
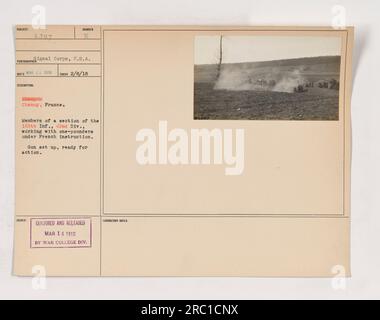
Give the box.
[194,34,341,121]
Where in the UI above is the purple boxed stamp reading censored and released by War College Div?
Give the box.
[30,217,92,249]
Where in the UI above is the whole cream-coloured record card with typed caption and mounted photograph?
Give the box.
[14,26,353,277]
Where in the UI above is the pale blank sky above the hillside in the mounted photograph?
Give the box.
[195,36,341,64]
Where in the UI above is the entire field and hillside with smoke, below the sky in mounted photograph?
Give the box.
[194,56,340,120]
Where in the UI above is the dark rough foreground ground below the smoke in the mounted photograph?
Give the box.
[194,83,339,120]
